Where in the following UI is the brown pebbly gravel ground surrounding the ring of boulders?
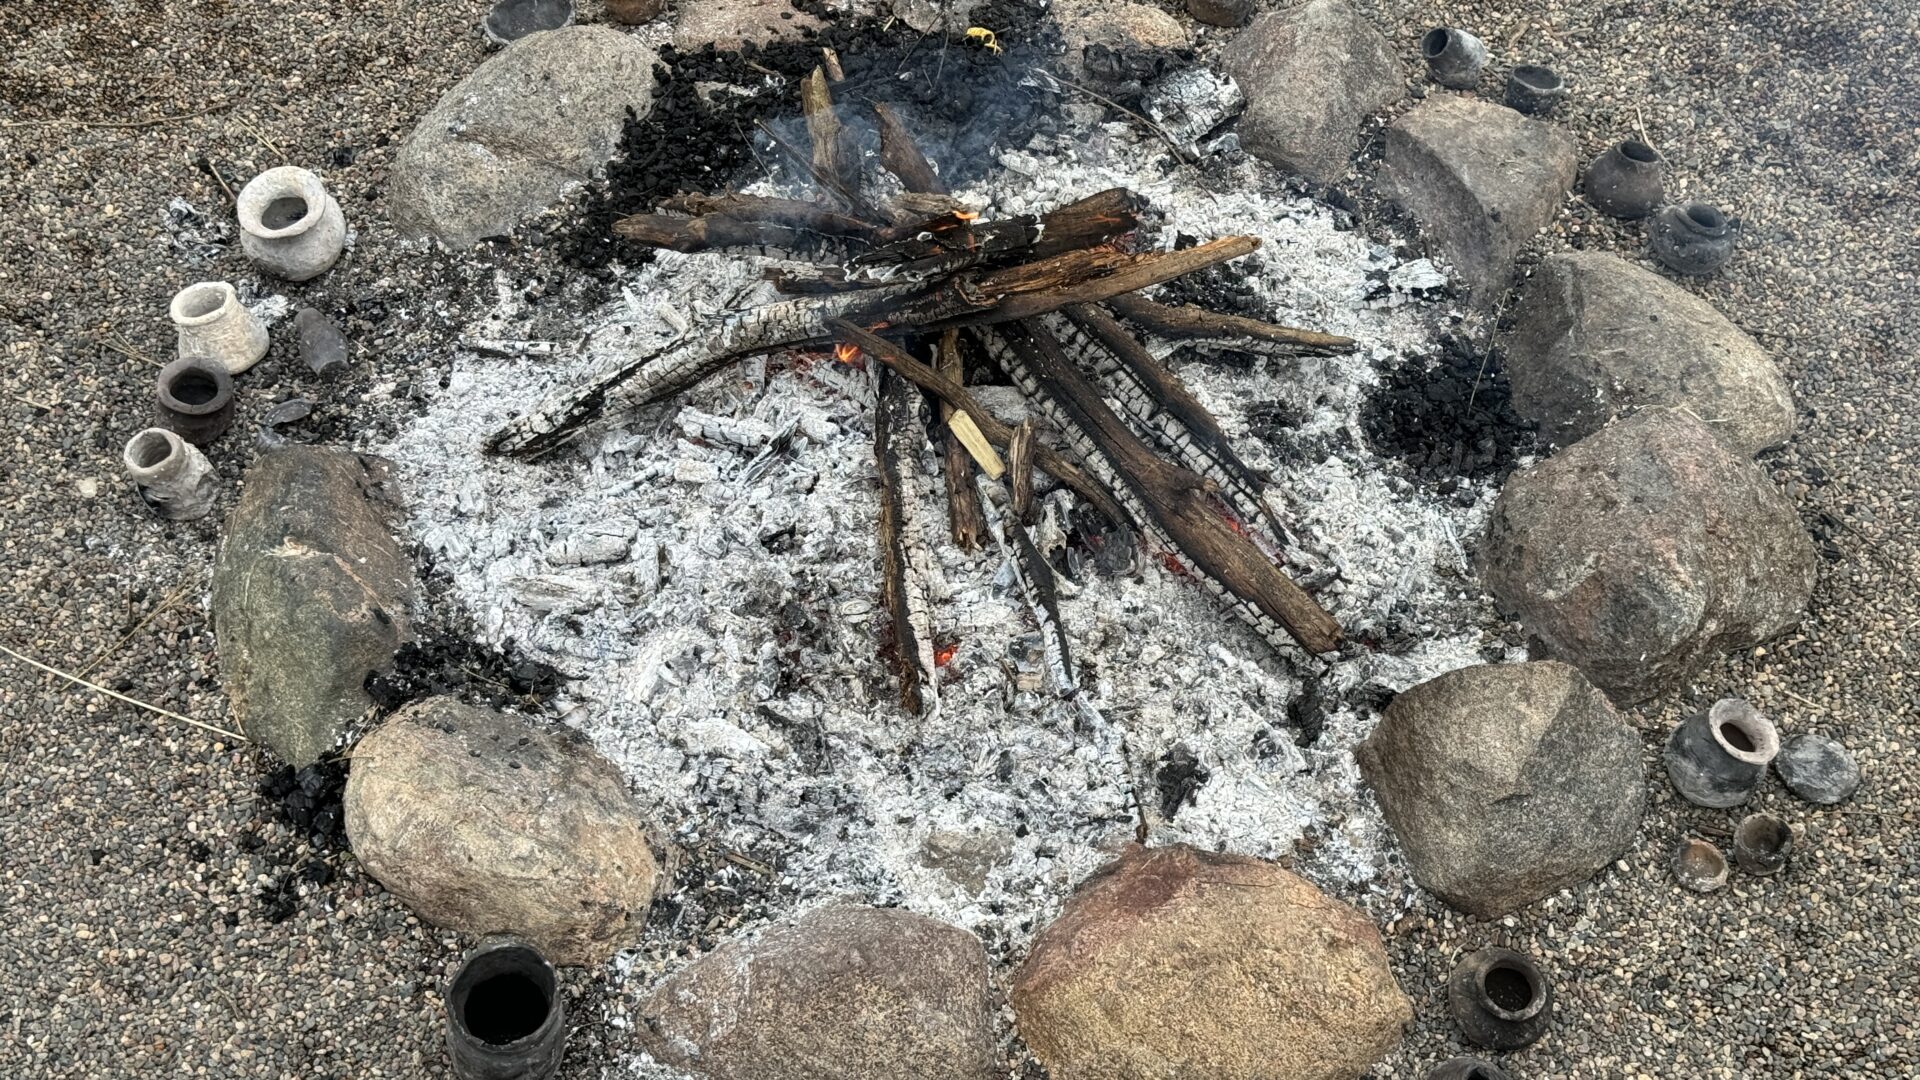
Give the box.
[0,0,1920,1078]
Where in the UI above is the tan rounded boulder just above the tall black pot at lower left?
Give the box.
[344,698,659,965]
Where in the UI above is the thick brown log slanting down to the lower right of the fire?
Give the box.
[993,323,1340,653]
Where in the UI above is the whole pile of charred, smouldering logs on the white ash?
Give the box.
[488,67,1354,713]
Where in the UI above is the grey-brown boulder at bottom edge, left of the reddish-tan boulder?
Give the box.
[639,905,1004,1080]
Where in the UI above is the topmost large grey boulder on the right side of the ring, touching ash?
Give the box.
[1219,0,1407,184]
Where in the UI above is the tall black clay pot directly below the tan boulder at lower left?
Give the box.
[445,938,566,1080]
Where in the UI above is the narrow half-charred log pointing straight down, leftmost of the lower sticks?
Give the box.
[874,371,939,715]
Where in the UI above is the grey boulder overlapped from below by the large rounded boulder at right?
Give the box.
[1507,252,1793,455]
